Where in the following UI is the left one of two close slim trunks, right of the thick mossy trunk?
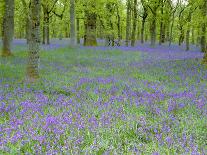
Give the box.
[126,0,131,46]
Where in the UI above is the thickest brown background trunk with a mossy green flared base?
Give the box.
[84,12,97,46]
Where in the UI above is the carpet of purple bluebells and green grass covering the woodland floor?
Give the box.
[0,40,207,155]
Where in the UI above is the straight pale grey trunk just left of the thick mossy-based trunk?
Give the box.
[70,0,76,46]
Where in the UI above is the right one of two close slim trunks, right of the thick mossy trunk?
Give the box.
[131,0,137,46]
